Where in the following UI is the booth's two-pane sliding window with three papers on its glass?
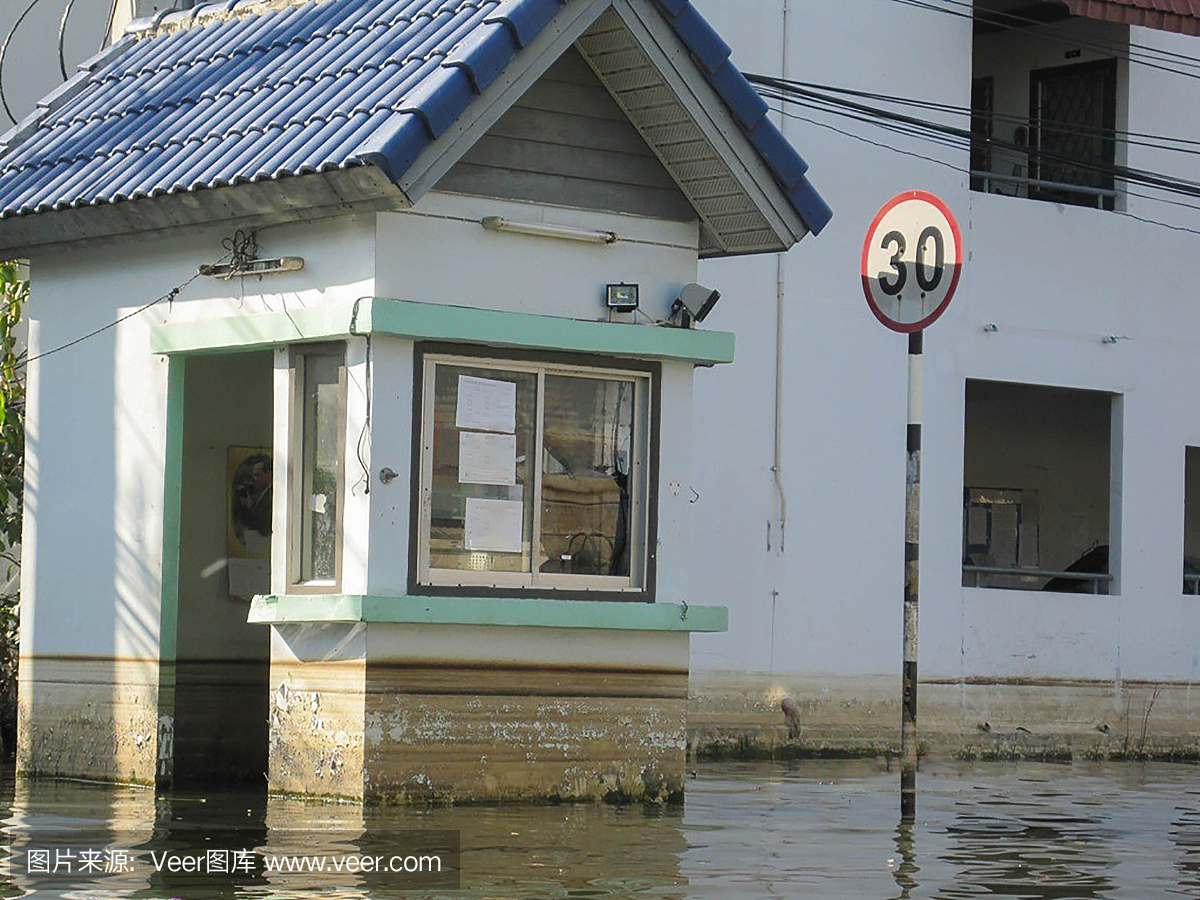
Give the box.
[416,354,650,600]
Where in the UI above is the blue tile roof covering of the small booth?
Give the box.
[0,0,830,233]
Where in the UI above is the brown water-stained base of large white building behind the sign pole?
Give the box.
[689,672,1200,760]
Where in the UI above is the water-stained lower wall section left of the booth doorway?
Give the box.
[17,656,158,785]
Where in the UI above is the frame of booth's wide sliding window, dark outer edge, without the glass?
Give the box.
[408,342,662,602]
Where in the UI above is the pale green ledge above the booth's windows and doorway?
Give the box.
[150,296,734,365]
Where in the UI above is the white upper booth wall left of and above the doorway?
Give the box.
[22,218,374,659]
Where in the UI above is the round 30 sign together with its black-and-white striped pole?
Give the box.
[862,191,962,823]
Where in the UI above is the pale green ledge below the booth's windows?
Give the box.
[247,594,730,632]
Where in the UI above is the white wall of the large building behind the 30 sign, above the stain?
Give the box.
[692,0,1200,696]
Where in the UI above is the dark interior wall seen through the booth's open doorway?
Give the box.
[174,352,274,782]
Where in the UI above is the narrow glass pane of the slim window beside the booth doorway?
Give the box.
[300,354,341,581]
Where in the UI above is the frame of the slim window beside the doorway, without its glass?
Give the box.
[287,342,347,594]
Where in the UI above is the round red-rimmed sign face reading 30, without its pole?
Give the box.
[863,191,962,334]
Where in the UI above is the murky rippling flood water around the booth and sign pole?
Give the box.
[0,761,1200,900]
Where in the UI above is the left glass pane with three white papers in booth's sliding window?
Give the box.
[430,365,538,572]
